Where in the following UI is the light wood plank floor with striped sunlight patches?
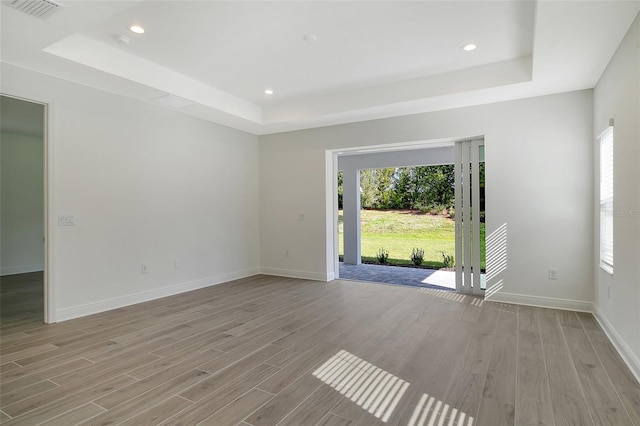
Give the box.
[0,276,640,426]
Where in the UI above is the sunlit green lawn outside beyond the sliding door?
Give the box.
[338,210,485,269]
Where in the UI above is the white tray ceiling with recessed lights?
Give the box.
[0,0,640,134]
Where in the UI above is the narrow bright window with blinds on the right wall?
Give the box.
[598,127,613,274]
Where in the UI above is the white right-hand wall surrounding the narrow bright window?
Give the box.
[593,15,640,377]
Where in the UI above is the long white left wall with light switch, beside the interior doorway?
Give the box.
[2,64,260,320]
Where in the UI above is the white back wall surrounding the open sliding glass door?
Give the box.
[260,90,593,310]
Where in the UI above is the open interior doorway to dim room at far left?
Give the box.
[0,95,48,327]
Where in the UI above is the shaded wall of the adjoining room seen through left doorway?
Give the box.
[0,131,44,275]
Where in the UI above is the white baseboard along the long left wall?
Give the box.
[55,268,260,322]
